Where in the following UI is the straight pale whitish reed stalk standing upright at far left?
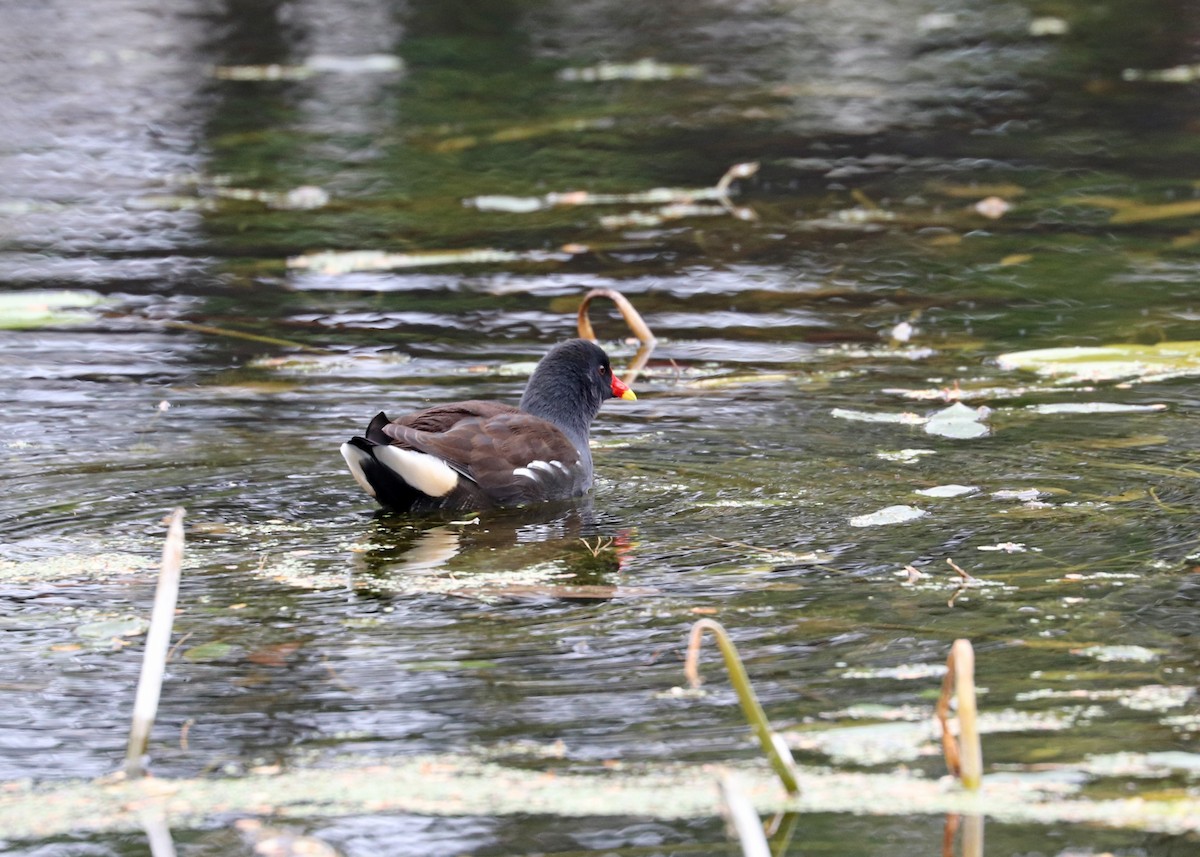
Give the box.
[125,509,184,779]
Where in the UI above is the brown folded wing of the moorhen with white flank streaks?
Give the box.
[384,408,592,505]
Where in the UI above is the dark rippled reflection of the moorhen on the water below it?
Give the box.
[359,498,634,599]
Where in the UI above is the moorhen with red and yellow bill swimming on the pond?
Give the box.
[341,340,637,513]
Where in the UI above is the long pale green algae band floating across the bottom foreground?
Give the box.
[0,755,1200,839]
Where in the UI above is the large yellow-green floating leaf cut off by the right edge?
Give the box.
[996,341,1200,384]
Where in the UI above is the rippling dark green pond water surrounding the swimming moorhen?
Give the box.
[0,0,1200,857]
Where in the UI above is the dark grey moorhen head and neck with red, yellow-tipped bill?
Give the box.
[521,340,636,457]
